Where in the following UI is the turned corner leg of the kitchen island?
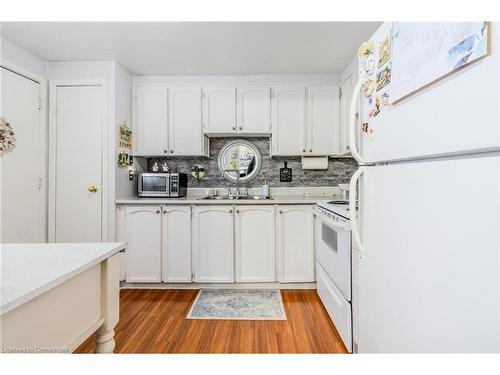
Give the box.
[95,253,120,353]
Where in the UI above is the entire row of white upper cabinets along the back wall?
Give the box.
[134,81,344,156]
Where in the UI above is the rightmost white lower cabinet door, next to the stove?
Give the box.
[276,206,314,282]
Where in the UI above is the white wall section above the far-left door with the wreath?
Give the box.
[0,38,47,77]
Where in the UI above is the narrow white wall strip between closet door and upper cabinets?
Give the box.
[115,64,137,198]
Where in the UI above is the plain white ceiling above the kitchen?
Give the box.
[2,22,380,75]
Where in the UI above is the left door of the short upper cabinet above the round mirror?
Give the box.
[203,87,236,134]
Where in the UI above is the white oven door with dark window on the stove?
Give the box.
[314,211,351,301]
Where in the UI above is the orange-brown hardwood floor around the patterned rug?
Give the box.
[76,289,346,353]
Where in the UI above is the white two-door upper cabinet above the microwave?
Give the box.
[133,86,208,156]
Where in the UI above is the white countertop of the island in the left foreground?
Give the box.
[0,242,127,315]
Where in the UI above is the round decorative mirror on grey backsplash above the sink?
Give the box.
[218,139,262,183]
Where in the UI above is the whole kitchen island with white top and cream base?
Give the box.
[0,243,126,353]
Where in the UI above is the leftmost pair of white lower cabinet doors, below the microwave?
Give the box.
[123,205,191,283]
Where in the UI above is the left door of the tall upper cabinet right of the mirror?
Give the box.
[271,87,306,156]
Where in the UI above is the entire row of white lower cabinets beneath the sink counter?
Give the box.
[119,204,315,283]
